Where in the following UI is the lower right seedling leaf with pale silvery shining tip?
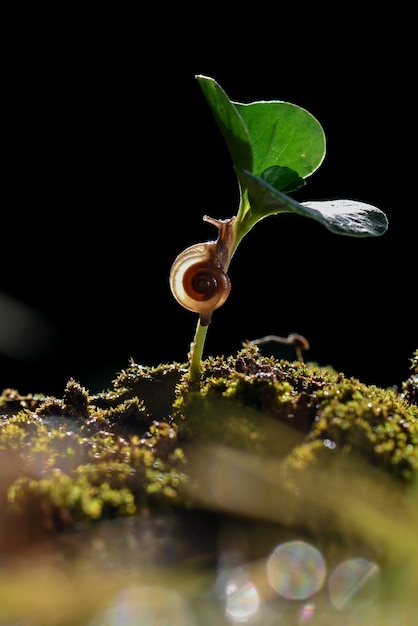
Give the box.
[235,170,388,239]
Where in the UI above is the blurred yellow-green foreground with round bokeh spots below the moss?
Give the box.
[0,438,418,626]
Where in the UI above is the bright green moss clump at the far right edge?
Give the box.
[288,379,418,480]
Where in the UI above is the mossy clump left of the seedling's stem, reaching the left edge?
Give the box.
[0,380,187,530]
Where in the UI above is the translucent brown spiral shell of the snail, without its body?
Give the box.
[170,241,231,316]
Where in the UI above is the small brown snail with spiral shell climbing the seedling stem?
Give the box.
[169,215,236,326]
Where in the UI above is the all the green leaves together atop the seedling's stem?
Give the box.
[196,75,388,254]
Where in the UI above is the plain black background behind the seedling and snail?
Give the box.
[0,8,418,395]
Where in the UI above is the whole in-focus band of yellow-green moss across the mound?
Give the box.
[0,346,418,548]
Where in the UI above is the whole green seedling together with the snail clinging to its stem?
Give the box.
[170,75,388,382]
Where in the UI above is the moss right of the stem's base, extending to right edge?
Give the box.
[174,348,418,479]
